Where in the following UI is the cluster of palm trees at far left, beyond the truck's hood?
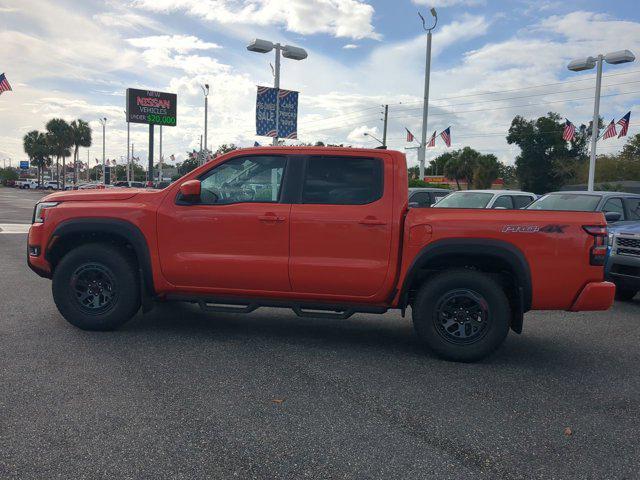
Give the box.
[22,118,92,188]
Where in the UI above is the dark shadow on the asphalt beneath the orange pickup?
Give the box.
[115,302,620,370]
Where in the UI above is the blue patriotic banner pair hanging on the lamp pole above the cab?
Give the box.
[256,87,298,139]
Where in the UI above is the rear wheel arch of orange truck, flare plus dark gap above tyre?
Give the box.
[400,238,532,333]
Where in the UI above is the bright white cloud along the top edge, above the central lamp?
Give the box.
[133,0,380,39]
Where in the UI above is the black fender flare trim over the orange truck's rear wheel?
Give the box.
[400,238,532,313]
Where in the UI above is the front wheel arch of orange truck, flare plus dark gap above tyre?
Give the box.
[44,218,155,296]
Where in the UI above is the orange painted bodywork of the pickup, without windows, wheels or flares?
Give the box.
[28,147,612,310]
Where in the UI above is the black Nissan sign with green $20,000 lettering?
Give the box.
[127,88,178,127]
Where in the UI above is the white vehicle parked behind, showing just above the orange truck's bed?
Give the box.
[433,190,538,210]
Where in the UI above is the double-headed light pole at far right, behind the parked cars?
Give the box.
[567,50,636,192]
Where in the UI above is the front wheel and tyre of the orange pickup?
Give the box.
[52,243,140,330]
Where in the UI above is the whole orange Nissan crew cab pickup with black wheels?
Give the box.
[28,147,615,361]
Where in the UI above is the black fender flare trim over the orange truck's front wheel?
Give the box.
[45,217,155,297]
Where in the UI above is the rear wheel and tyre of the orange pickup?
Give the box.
[413,270,511,362]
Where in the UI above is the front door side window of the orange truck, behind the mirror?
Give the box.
[200,156,286,204]
